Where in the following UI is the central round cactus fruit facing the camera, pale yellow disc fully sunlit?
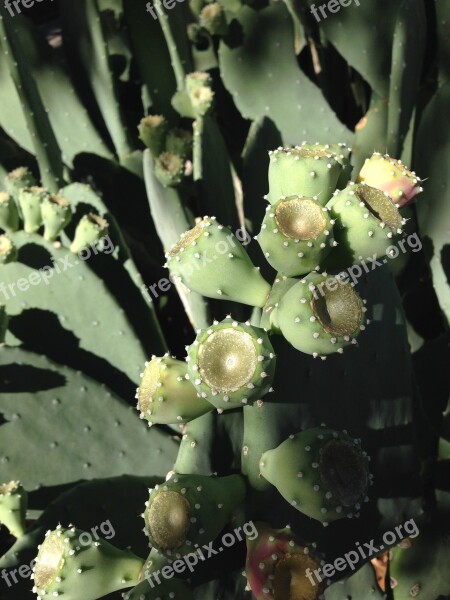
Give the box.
[188,318,276,410]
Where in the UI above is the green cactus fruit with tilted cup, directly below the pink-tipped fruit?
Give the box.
[324,182,406,269]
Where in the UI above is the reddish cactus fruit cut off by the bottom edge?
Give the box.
[245,523,325,600]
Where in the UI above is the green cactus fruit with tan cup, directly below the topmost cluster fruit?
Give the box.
[256,196,335,277]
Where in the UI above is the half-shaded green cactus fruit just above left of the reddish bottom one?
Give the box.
[143,474,245,564]
